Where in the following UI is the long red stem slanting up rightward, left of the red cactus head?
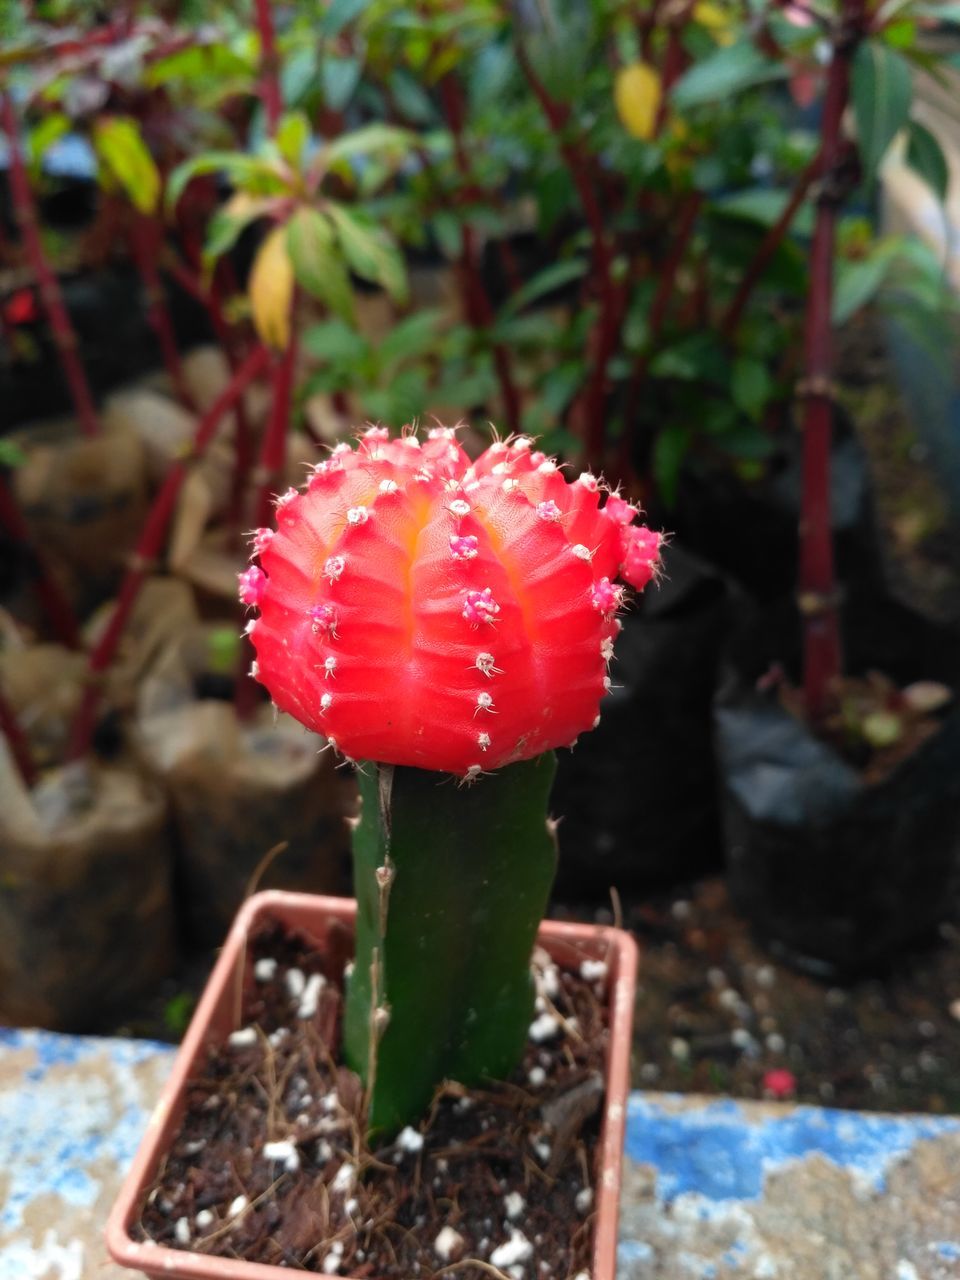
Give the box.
[68,347,269,760]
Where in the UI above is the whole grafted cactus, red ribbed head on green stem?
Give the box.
[241,428,660,1132]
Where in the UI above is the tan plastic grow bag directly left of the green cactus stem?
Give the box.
[137,626,356,946]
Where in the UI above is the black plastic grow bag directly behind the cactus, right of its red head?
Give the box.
[550,545,730,897]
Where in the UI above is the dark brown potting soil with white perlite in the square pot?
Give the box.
[134,929,607,1280]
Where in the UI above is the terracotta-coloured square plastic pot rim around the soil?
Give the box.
[106,891,637,1280]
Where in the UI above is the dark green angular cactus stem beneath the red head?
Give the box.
[344,753,557,1135]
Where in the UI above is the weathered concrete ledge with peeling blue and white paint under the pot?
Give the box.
[0,1029,960,1280]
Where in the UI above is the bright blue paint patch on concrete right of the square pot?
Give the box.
[626,1093,960,1212]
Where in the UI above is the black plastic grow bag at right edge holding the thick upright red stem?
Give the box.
[716,605,960,980]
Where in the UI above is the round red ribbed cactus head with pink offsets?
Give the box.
[241,428,660,777]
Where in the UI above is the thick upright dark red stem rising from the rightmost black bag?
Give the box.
[799,0,865,724]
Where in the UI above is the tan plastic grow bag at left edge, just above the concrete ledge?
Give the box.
[0,739,175,1032]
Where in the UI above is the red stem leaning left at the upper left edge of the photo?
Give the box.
[0,91,100,435]
